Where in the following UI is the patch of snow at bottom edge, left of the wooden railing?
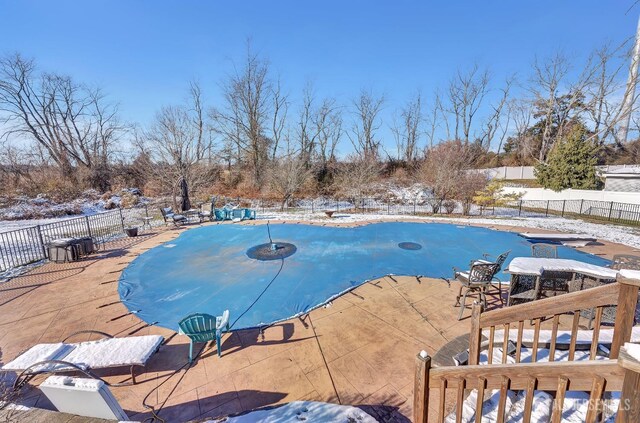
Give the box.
[204,401,377,423]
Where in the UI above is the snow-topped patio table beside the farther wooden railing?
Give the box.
[507,257,618,305]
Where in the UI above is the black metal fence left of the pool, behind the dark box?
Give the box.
[0,206,162,272]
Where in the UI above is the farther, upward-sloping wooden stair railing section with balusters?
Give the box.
[469,278,640,365]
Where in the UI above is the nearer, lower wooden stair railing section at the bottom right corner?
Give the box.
[413,352,640,423]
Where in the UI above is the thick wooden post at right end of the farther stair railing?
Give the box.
[609,278,640,360]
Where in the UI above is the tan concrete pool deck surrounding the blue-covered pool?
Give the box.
[0,219,637,422]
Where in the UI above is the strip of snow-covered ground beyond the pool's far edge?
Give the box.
[258,212,640,249]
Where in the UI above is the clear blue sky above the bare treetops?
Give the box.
[0,0,640,154]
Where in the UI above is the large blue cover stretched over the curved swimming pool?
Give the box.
[118,223,608,330]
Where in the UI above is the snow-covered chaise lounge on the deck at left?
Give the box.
[0,330,164,388]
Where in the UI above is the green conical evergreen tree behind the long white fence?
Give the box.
[535,123,602,191]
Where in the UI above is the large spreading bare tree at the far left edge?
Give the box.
[0,54,125,187]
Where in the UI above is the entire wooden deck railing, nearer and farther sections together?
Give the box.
[414,279,640,423]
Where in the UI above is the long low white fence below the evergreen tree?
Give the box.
[502,187,640,204]
